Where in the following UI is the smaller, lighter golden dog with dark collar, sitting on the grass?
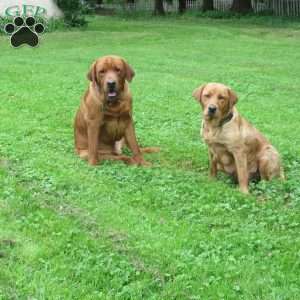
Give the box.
[193,83,284,193]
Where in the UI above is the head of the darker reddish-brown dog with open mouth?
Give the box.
[87,56,134,104]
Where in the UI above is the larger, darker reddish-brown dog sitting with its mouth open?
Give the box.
[74,56,159,165]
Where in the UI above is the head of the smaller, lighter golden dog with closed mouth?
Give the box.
[193,83,238,121]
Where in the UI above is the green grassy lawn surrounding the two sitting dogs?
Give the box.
[0,17,300,300]
